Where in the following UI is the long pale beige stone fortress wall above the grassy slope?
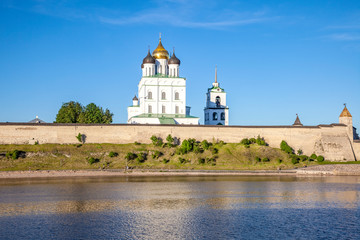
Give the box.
[0,123,354,161]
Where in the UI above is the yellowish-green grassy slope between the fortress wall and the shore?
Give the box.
[0,143,330,171]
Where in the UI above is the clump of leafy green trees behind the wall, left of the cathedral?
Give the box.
[55,101,114,124]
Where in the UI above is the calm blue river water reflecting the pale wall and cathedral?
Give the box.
[0,176,360,239]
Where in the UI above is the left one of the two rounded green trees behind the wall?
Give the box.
[55,101,83,123]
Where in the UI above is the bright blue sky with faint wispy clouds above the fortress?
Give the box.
[0,0,360,128]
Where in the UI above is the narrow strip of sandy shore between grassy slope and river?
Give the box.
[0,164,360,179]
